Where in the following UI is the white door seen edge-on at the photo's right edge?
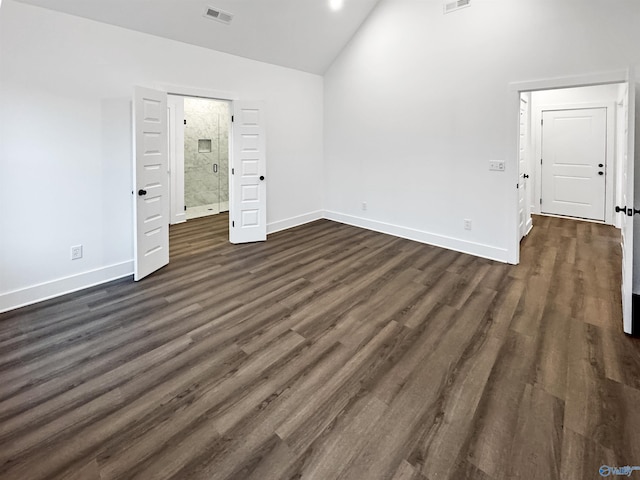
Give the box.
[616,79,640,334]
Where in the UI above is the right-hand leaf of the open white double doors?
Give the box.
[229,101,267,243]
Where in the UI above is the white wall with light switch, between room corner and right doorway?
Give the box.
[324,0,640,260]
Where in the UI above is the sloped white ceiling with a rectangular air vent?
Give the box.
[19,0,379,74]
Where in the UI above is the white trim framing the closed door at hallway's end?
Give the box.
[532,102,618,225]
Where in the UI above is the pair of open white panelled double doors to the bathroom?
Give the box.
[132,87,267,281]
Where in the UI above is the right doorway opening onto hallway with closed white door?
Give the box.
[518,82,626,246]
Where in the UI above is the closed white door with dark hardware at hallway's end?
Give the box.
[540,108,607,221]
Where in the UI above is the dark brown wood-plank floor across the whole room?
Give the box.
[0,215,640,480]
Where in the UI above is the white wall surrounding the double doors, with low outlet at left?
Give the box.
[0,0,323,311]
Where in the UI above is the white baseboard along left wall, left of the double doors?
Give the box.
[0,260,133,313]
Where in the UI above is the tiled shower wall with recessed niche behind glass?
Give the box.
[184,97,230,210]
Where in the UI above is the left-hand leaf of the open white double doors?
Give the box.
[133,87,169,281]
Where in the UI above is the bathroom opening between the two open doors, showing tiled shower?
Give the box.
[167,95,231,224]
